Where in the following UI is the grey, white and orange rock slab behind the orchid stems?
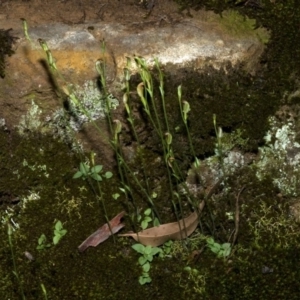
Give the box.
[0,7,263,127]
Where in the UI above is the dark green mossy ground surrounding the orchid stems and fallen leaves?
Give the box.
[0,0,300,299]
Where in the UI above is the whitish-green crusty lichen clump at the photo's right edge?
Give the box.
[255,117,300,197]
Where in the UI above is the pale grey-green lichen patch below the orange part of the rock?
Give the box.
[16,81,119,149]
